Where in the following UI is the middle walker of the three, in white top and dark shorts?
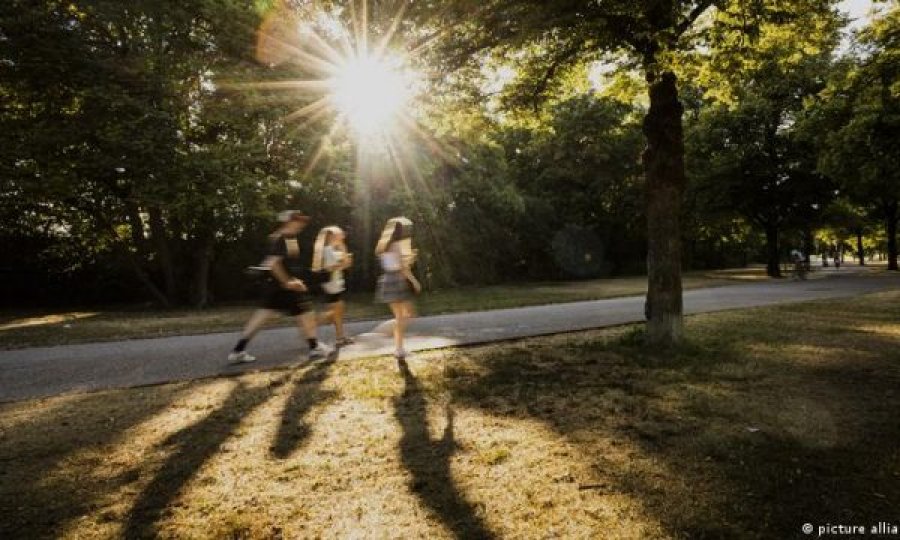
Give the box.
[312,226,353,347]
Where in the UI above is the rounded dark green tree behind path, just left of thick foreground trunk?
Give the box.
[497,93,646,278]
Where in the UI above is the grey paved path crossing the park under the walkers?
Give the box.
[0,269,900,402]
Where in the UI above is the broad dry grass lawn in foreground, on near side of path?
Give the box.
[0,291,900,539]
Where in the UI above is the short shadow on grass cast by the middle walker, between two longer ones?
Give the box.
[271,350,339,459]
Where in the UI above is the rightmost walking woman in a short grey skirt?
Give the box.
[375,217,422,360]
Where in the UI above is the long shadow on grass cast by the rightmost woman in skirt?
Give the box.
[394,360,493,538]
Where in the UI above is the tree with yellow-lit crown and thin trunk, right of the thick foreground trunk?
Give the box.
[683,4,842,277]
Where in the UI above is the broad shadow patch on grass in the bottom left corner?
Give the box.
[0,385,186,538]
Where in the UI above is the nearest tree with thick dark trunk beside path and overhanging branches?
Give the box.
[413,0,848,344]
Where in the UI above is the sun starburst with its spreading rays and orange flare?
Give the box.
[244,0,458,176]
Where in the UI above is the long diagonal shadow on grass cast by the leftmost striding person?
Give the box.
[123,375,289,538]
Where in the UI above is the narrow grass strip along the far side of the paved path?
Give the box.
[0,268,768,350]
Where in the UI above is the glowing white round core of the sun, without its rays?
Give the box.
[328,56,413,137]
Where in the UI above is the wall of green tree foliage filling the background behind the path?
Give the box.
[0,0,900,305]
